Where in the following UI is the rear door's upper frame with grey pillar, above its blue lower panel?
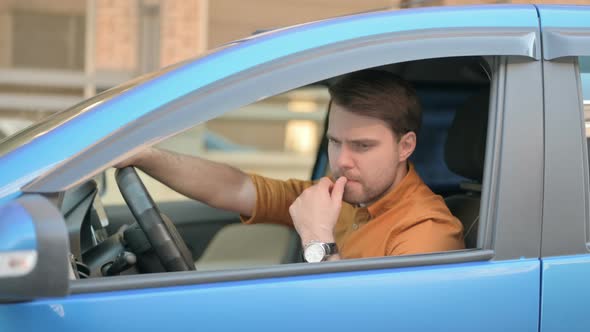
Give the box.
[537,5,590,257]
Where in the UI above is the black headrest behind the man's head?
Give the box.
[445,88,490,183]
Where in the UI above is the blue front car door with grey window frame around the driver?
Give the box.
[0,6,544,331]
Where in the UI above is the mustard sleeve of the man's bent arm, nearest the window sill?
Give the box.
[388,219,465,256]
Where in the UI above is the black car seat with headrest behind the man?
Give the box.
[445,87,489,248]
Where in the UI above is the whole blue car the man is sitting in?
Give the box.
[0,5,590,332]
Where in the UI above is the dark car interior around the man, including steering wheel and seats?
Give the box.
[51,56,492,279]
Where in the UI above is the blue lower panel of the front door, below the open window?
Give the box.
[0,259,539,332]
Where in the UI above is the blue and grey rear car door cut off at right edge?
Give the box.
[539,6,590,331]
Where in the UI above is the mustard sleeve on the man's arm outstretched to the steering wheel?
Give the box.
[240,174,313,227]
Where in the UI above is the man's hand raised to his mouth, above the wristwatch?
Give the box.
[289,176,346,249]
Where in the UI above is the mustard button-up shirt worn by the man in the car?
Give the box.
[242,164,465,258]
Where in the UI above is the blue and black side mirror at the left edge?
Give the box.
[0,195,70,302]
